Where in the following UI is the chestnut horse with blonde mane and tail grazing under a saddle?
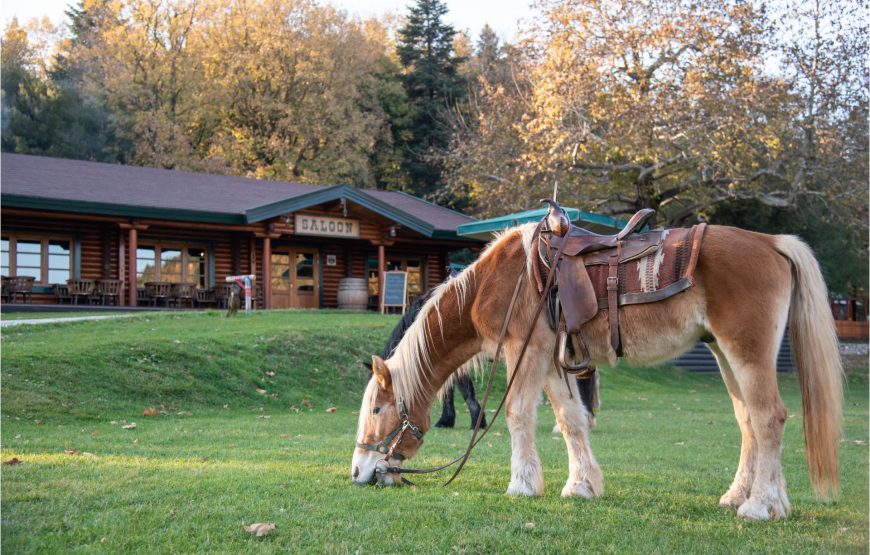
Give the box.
[351,224,842,520]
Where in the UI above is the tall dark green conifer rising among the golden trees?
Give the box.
[397,0,465,201]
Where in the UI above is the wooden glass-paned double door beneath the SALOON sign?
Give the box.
[270,249,320,308]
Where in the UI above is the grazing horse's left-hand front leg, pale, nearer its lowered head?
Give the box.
[505,347,548,496]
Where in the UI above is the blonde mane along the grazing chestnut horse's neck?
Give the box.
[387,224,535,403]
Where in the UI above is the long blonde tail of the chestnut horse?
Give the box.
[776,235,843,499]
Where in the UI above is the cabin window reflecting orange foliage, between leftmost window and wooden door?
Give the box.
[136,241,208,288]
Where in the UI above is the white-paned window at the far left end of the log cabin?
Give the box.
[0,235,73,286]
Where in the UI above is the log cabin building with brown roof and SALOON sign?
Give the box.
[0,153,482,308]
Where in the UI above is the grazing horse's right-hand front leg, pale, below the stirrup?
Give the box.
[544,369,604,498]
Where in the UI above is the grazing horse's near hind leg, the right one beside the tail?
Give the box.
[720,338,791,520]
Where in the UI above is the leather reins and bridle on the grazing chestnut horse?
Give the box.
[356,218,567,486]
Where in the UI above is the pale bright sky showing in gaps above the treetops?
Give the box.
[0,0,532,41]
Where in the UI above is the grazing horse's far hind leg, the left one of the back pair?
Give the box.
[707,343,756,509]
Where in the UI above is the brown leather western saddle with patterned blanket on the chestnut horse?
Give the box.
[536,200,706,373]
